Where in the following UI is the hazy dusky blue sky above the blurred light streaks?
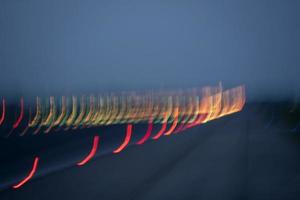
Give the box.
[0,0,300,100]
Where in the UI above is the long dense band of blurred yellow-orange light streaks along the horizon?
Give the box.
[0,84,246,137]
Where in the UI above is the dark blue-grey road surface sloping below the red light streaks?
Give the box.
[0,104,300,200]
